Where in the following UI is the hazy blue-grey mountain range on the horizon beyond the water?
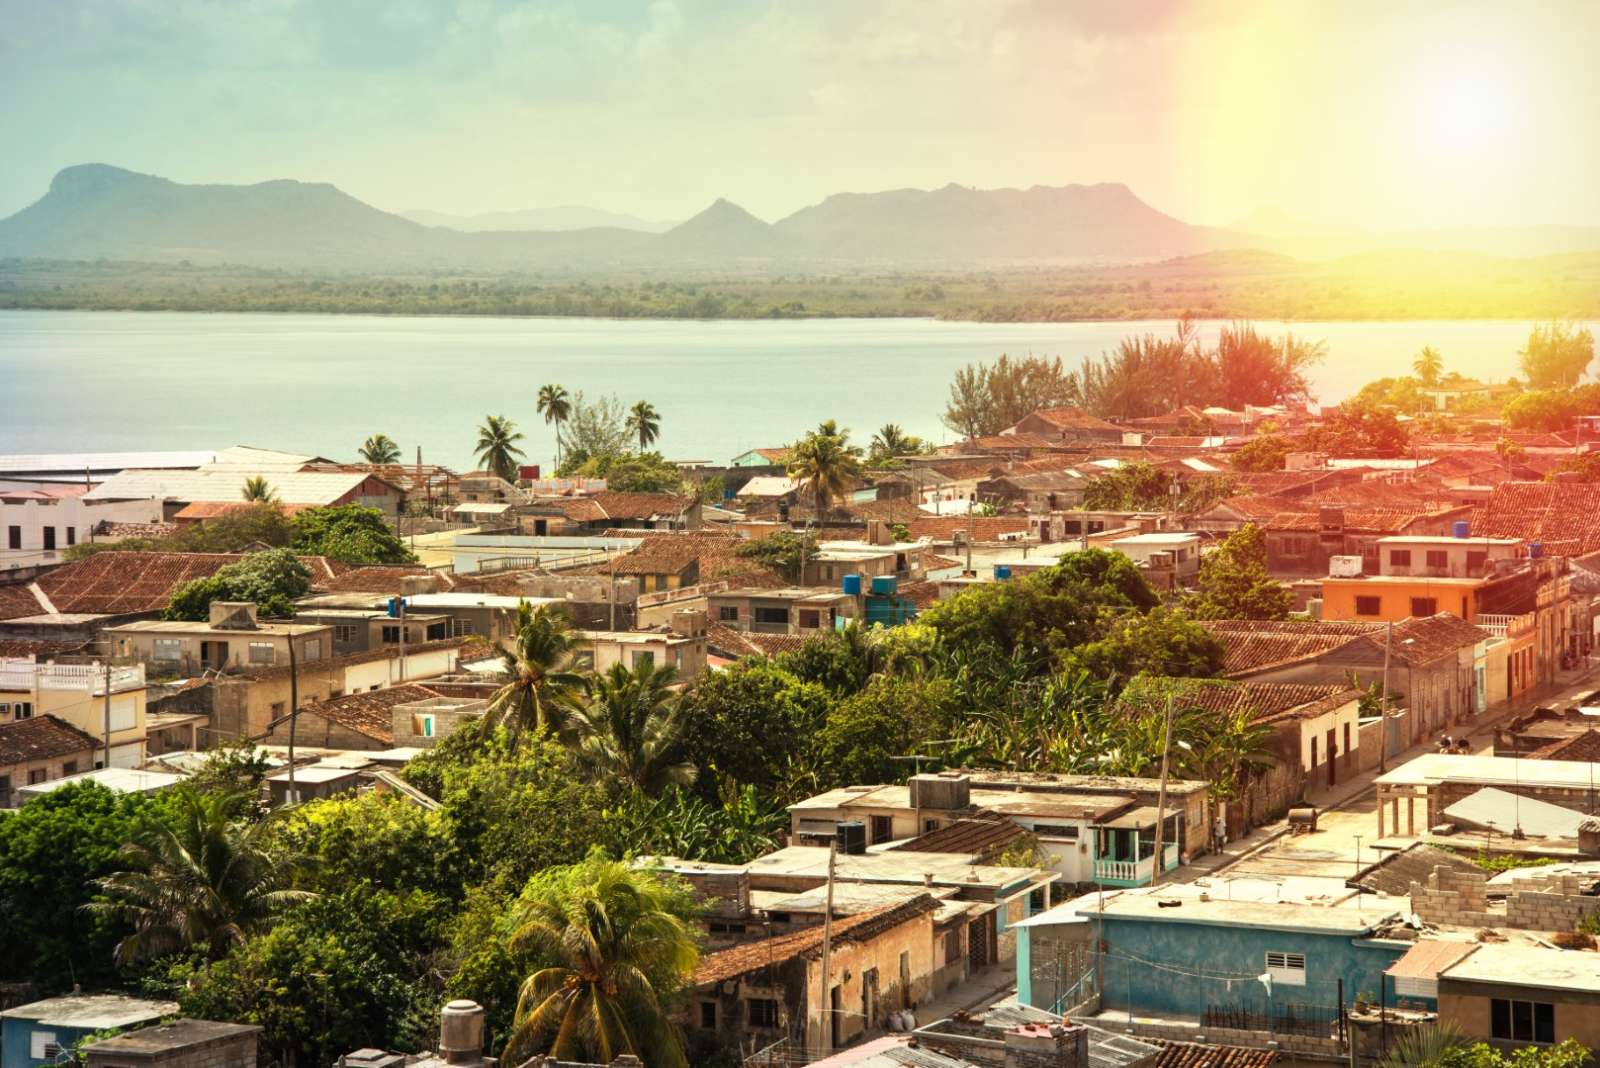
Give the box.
[0,163,1600,270]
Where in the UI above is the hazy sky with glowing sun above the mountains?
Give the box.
[0,0,1600,227]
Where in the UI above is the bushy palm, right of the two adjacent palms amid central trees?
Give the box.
[573,664,694,796]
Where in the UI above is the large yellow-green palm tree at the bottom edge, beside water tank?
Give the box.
[506,855,699,1068]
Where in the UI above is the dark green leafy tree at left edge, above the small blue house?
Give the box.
[0,783,165,994]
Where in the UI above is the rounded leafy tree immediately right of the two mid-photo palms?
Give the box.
[682,659,830,799]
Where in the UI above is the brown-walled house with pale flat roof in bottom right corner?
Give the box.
[1437,943,1600,1049]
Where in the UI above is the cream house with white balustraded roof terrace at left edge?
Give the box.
[0,660,147,771]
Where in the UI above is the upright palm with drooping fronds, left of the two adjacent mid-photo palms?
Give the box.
[483,601,584,737]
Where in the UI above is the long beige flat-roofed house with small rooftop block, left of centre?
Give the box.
[104,601,333,676]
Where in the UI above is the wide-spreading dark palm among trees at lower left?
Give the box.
[88,788,315,964]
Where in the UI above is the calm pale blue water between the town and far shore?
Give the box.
[0,312,1574,467]
